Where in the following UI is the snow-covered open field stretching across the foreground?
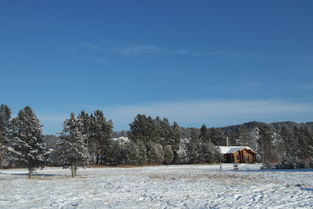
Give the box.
[0,164,313,209]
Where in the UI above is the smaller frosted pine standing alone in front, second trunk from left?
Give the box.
[59,113,90,177]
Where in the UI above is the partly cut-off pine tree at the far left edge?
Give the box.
[0,104,12,168]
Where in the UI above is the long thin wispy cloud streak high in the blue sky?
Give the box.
[83,43,268,59]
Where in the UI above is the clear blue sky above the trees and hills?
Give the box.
[0,0,313,134]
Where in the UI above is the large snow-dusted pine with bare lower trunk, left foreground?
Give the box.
[9,106,48,178]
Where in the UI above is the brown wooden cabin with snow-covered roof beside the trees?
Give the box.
[219,146,257,163]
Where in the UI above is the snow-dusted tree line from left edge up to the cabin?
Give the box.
[0,105,221,177]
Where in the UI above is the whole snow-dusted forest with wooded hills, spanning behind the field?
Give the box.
[0,104,313,177]
